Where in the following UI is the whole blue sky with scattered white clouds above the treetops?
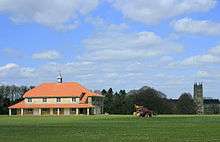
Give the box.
[0,0,220,98]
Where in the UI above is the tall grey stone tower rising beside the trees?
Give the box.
[193,83,204,114]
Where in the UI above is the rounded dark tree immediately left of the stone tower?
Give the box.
[177,93,196,114]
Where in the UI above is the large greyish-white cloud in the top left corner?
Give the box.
[0,0,99,31]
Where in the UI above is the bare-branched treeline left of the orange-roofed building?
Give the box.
[0,85,34,114]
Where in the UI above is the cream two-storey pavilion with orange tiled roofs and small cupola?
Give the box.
[9,75,104,115]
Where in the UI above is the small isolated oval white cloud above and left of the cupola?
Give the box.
[32,50,61,60]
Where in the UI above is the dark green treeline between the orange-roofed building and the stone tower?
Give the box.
[101,87,196,114]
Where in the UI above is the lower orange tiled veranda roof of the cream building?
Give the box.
[8,101,94,109]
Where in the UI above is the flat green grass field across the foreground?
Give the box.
[0,115,220,142]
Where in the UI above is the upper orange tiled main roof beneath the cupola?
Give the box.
[23,82,102,98]
